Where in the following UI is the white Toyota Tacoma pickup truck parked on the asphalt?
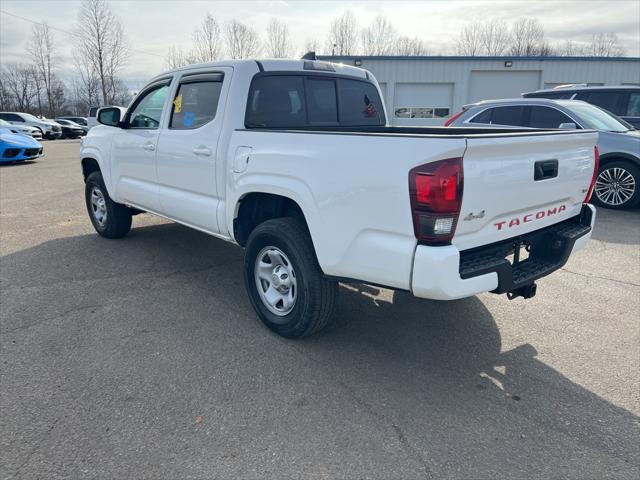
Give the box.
[81,60,598,338]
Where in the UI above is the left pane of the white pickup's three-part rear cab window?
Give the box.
[246,75,307,128]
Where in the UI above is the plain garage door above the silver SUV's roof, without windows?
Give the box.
[468,70,540,103]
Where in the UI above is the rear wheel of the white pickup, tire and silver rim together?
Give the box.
[244,218,338,338]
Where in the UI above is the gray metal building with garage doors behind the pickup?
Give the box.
[318,56,640,125]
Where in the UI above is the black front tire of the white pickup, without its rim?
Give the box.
[84,172,131,238]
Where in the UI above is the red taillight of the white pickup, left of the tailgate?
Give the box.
[409,158,463,245]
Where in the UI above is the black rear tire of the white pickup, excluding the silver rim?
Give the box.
[244,218,338,338]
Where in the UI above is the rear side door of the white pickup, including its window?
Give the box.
[157,67,232,233]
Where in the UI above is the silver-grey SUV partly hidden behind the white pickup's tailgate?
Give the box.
[449,98,640,209]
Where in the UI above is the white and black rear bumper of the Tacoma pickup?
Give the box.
[411,205,595,300]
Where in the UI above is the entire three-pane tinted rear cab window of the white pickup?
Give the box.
[245,75,385,128]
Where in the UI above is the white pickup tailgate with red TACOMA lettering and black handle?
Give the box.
[452,132,597,250]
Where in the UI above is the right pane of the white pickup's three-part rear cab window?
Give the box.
[338,78,385,126]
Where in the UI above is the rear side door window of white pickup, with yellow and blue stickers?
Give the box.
[169,81,222,129]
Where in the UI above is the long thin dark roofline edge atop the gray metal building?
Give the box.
[317,55,640,62]
